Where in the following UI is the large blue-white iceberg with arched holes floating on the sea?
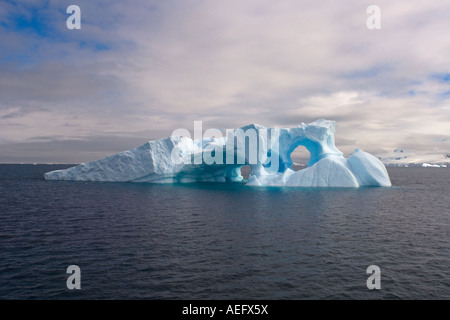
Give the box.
[44,119,391,188]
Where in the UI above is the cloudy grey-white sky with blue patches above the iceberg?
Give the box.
[0,0,450,163]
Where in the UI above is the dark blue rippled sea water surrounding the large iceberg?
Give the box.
[0,165,450,299]
